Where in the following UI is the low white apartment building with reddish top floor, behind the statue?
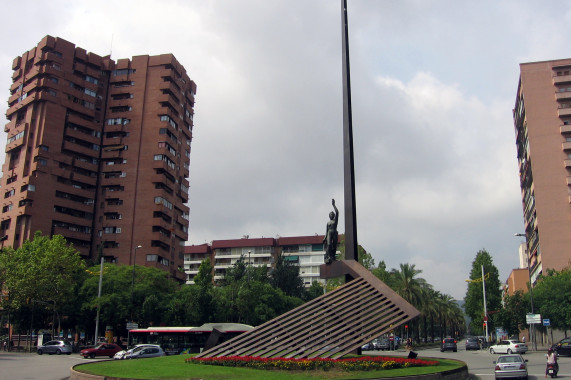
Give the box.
[184,235,332,287]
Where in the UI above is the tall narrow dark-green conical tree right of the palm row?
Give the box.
[464,250,502,334]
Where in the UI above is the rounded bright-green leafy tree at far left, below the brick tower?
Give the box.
[0,231,84,334]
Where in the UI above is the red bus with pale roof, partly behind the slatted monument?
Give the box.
[129,323,253,355]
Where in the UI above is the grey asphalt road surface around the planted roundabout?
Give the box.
[0,345,571,380]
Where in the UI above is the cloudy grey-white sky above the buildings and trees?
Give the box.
[0,0,571,299]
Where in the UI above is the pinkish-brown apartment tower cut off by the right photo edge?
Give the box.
[513,59,571,283]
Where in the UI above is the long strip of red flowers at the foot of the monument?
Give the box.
[185,356,438,371]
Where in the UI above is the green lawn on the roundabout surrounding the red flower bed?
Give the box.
[75,355,463,380]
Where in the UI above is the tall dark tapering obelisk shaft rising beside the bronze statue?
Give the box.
[341,0,358,261]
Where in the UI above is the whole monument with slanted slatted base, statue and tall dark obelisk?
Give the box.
[197,0,420,358]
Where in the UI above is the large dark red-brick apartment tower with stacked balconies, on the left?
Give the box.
[0,36,196,279]
